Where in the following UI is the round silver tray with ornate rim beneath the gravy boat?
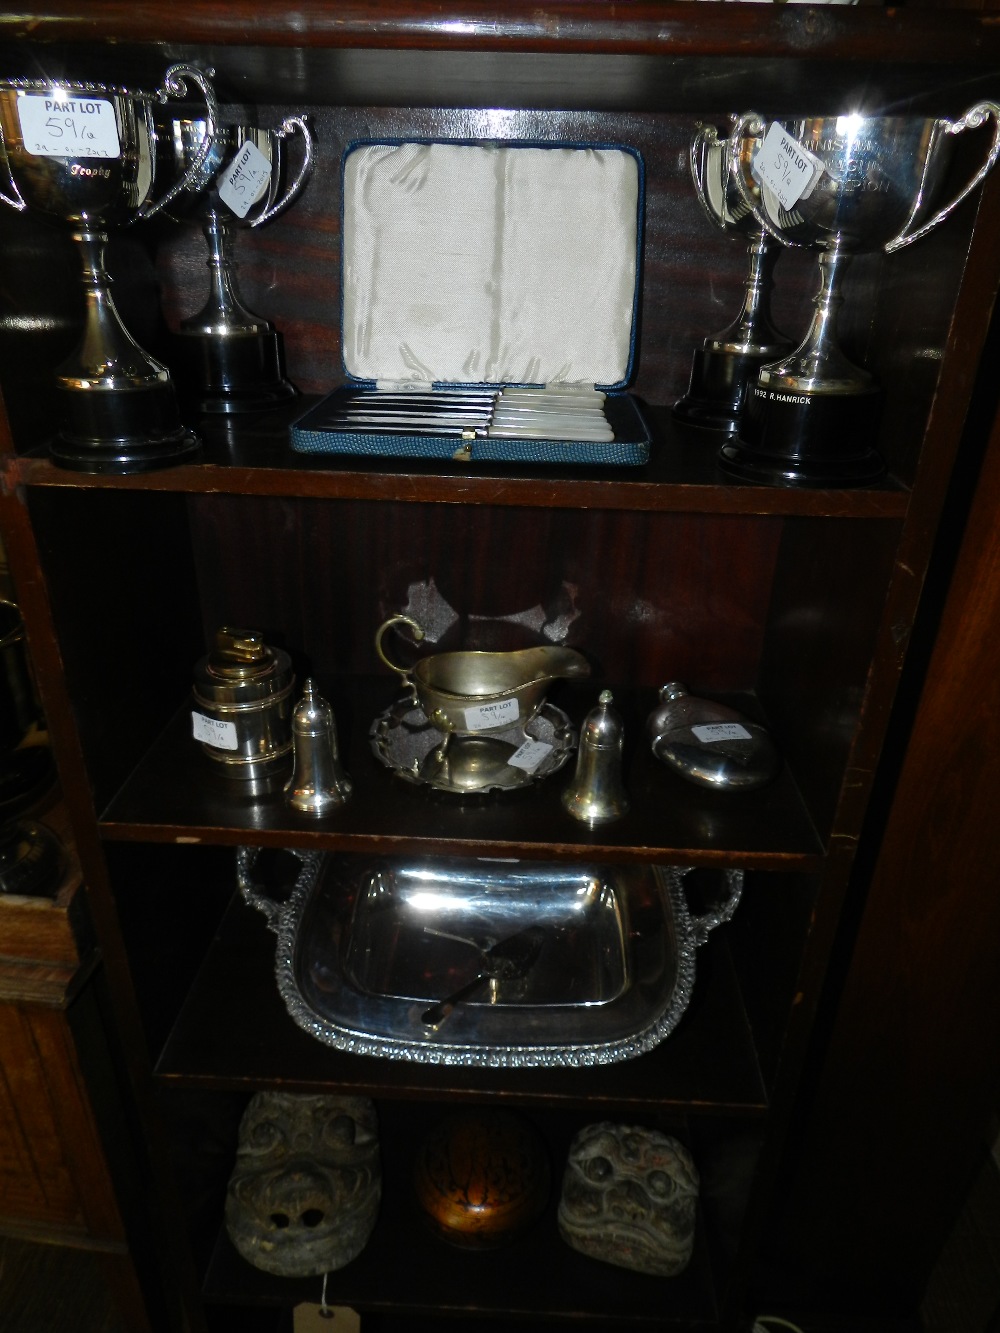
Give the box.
[368,694,576,796]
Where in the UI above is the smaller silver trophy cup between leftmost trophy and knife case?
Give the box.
[160,116,312,413]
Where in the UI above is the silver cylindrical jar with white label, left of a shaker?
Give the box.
[191,625,295,789]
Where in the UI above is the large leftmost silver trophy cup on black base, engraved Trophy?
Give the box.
[0,64,216,473]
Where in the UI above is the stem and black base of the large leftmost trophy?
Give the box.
[51,229,200,472]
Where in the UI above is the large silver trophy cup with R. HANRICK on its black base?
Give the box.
[720,101,1000,487]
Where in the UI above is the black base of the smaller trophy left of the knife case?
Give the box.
[176,329,299,413]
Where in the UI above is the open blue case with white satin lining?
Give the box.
[291,140,649,467]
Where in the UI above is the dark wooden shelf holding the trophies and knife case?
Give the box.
[7,397,909,519]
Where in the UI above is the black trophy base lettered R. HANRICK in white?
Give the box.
[719,387,885,488]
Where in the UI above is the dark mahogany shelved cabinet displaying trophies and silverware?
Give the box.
[0,0,1000,1330]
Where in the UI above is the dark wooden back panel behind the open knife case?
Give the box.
[160,107,821,403]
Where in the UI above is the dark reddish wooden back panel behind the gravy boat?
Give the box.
[191,497,781,690]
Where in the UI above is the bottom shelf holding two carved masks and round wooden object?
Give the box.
[204,1104,716,1330]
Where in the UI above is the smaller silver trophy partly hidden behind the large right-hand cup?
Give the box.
[673,125,793,432]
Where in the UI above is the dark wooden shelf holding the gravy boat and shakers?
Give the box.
[100,677,823,870]
